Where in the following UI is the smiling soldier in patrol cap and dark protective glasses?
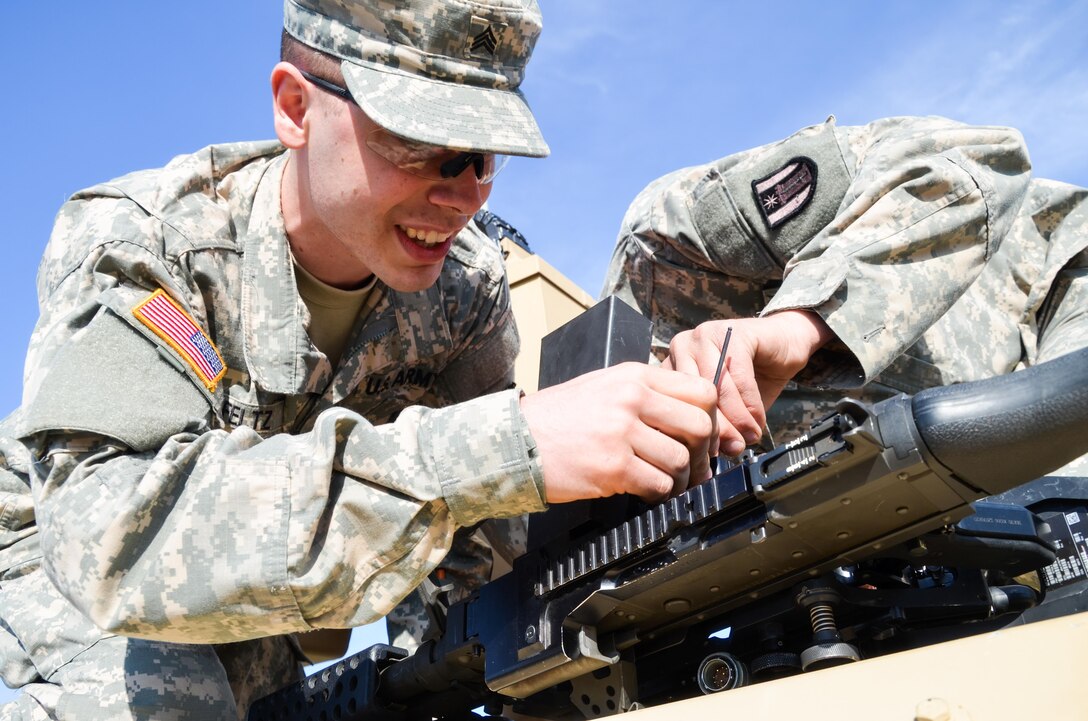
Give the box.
[0,0,716,720]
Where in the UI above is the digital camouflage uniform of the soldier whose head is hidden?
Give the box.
[603,117,1088,476]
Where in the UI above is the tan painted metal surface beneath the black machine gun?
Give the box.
[625,612,1088,721]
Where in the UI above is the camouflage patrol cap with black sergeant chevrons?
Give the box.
[283,0,548,158]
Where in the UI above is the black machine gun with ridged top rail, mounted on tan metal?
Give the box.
[249,297,1088,721]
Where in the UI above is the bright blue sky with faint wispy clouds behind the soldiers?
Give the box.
[0,0,1088,699]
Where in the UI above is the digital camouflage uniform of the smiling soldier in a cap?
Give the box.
[0,144,544,718]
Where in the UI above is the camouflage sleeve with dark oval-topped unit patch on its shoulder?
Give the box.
[605,117,1029,387]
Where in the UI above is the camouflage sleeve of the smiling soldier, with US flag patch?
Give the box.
[22,237,544,643]
